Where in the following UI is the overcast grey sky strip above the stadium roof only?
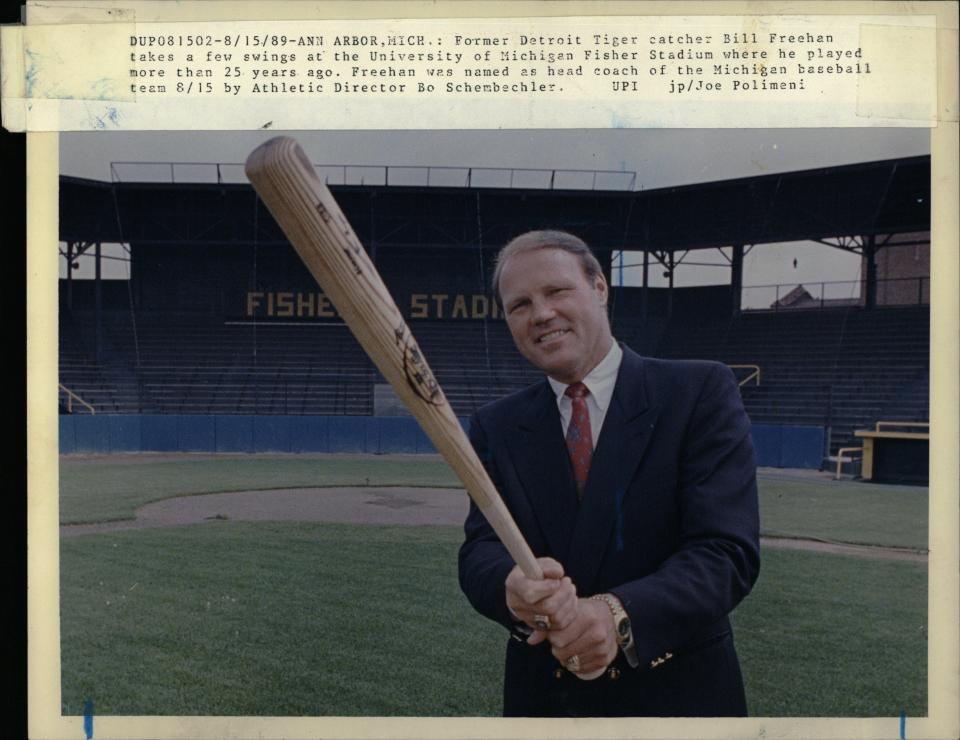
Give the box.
[60,128,930,190]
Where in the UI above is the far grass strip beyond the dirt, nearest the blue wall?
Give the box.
[60,455,928,549]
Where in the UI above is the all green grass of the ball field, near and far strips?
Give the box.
[61,456,927,716]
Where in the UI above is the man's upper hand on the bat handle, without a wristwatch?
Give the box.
[505,558,577,645]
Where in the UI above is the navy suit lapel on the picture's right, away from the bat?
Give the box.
[565,347,659,594]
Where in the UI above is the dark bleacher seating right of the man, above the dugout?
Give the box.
[659,307,930,452]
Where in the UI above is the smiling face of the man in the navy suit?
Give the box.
[500,247,613,383]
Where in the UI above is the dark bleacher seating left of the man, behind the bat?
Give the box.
[60,311,537,415]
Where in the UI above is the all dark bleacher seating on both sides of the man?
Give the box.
[60,308,929,451]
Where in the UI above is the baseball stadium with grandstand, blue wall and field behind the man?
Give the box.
[58,134,931,718]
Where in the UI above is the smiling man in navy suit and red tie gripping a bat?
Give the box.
[460,231,760,717]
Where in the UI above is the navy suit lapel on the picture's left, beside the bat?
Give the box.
[509,379,578,561]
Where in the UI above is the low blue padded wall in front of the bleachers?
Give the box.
[60,414,824,469]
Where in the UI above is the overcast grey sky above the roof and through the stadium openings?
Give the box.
[60,128,930,303]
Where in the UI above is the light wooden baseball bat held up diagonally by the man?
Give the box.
[246,136,543,579]
